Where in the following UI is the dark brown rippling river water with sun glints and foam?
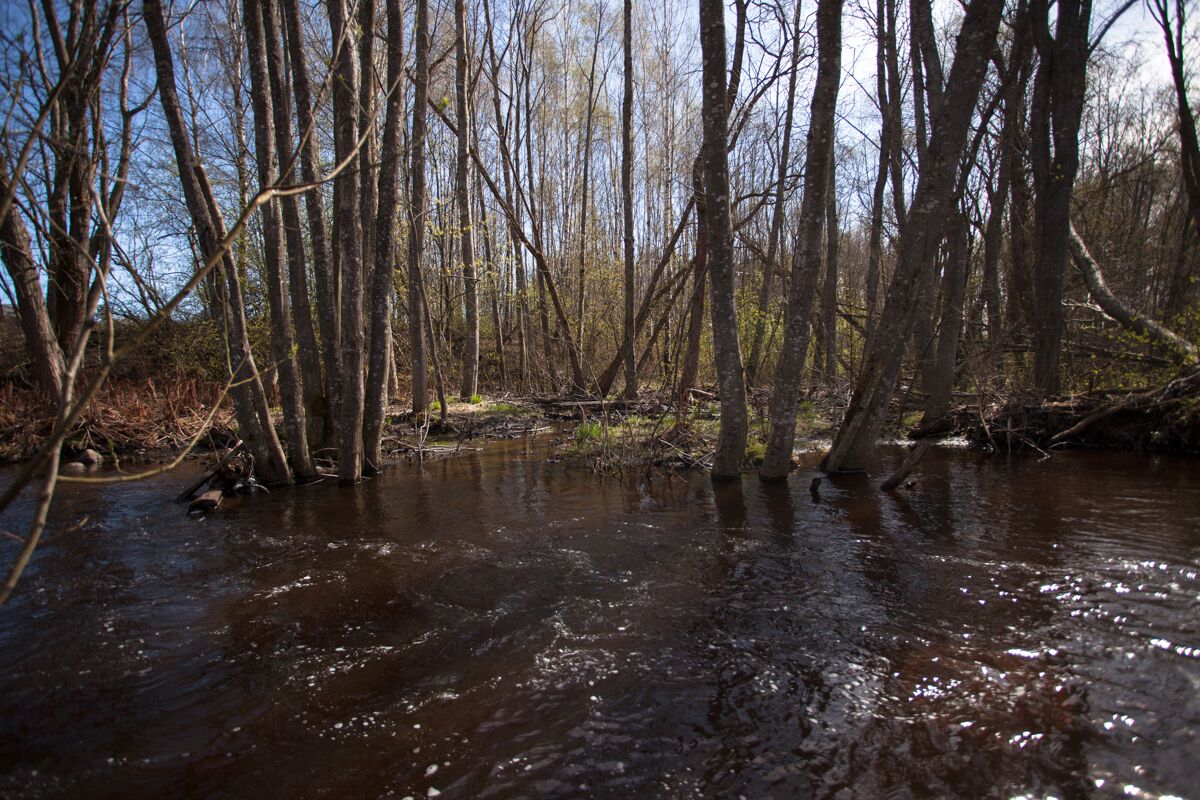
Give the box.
[0,440,1200,799]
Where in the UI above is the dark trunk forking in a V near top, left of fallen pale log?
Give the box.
[1031,0,1092,396]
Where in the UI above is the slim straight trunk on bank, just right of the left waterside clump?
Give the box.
[407,0,430,415]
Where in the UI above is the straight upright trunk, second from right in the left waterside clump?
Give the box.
[328,0,364,483]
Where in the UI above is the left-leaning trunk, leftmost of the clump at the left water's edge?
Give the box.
[143,0,292,483]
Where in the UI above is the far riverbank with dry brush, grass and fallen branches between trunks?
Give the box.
[0,371,1200,471]
